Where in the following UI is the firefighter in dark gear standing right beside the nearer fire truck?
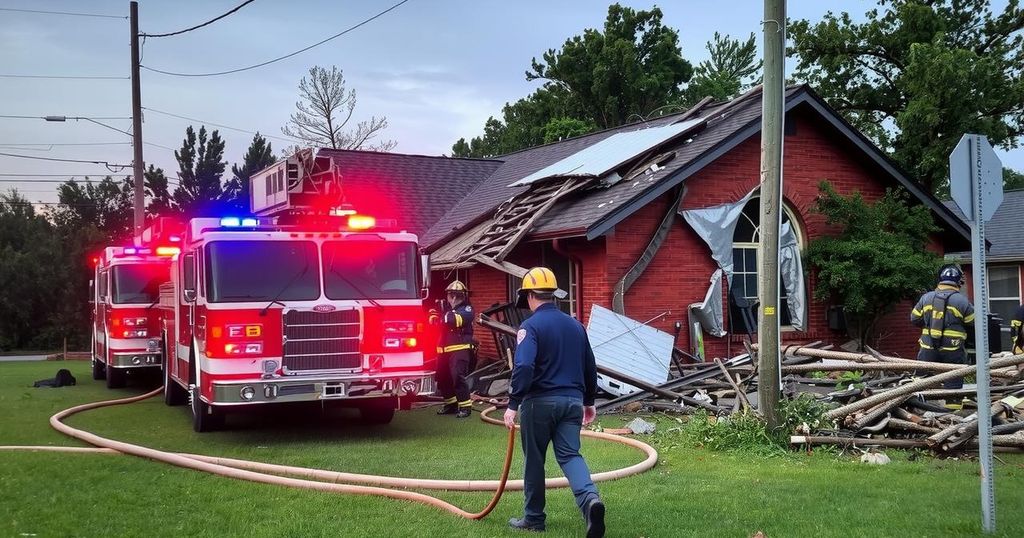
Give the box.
[431,281,473,418]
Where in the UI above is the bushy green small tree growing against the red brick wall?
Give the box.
[807,181,942,348]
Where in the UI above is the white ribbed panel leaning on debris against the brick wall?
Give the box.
[587,304,675,396]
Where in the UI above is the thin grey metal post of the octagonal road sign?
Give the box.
[970,135,995,533]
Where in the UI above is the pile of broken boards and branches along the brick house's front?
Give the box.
[471,301,1024,454]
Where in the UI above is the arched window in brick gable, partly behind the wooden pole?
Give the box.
[729,198,802,332]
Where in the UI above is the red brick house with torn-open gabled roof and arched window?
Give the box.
[333,86,970,358]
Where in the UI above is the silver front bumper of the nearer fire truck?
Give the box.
[212,372,434,406]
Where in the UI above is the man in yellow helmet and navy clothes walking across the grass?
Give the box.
[505,267,604,538]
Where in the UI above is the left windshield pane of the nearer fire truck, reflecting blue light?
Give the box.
[204,241,319,302]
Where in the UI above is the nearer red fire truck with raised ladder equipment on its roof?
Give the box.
[160,153,436,431]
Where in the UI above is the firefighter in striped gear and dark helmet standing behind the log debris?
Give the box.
[910,265,974,407]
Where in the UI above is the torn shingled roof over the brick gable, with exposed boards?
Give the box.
[423,85,970,255]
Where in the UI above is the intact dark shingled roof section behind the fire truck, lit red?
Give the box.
[318,150,502,238]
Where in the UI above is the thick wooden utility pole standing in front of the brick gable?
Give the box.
[758,0,785,427]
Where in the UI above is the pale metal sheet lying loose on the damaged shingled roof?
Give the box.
[509,119,705,187]
